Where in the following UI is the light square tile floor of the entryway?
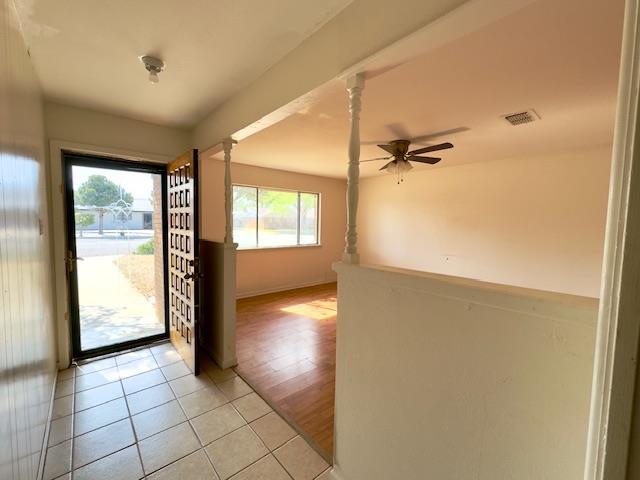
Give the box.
[44,344,329,480]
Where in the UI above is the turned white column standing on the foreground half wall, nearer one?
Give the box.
[342,73,364,264]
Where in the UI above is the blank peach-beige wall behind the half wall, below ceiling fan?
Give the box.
[358,147,611,297]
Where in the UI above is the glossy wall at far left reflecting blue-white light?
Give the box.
[0,0,56,480]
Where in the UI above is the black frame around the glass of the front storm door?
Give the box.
[62,151,169,360]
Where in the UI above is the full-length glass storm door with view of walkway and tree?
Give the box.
[67,157,167,356]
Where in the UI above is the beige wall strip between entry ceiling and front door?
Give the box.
[45,102,191,157]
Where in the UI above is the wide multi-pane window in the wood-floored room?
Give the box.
[233,185,320,248]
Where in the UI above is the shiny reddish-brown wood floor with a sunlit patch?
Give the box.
[236,283,336,458]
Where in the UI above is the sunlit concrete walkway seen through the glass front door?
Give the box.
[77,255,164,350]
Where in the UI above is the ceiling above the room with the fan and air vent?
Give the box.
[224,0,624,177]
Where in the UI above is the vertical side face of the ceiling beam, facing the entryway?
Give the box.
[194,0,465,150]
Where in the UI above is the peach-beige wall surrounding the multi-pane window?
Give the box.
[200,160,346,296]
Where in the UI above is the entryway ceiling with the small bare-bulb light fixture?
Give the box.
[16,0,351,127]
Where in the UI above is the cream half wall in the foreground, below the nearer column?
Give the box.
[334,264,597,480]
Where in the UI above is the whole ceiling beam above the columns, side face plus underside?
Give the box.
[194,0,534,151]
